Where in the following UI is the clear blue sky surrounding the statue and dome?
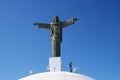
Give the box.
[0,0,120,80]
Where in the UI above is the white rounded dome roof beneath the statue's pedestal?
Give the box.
[19,72,94,80]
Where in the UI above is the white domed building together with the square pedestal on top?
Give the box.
[19,57,94,80]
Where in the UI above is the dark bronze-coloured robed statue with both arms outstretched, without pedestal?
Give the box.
[34,16,78,57]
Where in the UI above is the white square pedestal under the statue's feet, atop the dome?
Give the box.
[49,57,61,72]
